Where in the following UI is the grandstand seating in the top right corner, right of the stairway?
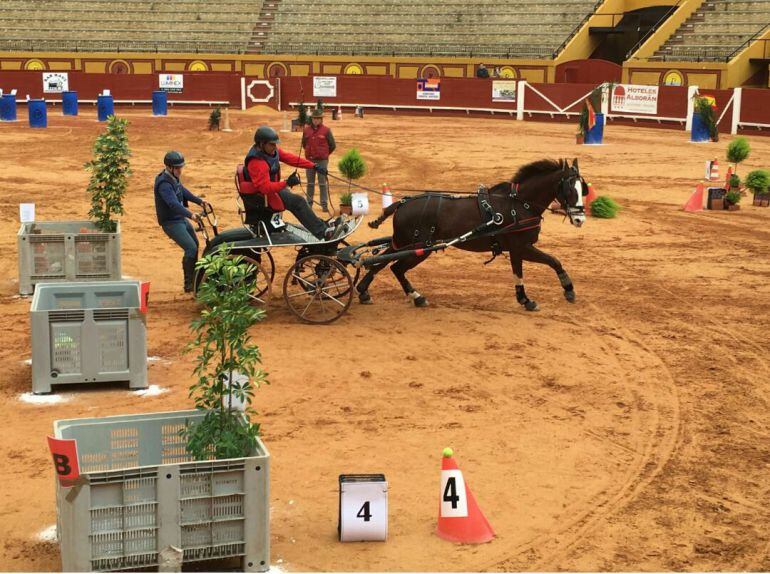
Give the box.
[650,0,770,61]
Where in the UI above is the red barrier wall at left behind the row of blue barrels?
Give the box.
[0,71,241,107]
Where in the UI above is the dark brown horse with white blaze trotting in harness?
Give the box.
[357,159,587,311]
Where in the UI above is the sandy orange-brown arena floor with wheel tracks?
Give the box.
[0,110,770,571]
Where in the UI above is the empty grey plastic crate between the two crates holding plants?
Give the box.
[30,280,147,393]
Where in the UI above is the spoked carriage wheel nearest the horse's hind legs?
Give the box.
[283,255,353,324]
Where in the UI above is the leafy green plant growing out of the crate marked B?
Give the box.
[180,247,268,460]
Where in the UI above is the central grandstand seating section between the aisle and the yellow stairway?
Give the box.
[255,0,596,58]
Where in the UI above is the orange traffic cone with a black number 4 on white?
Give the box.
[436,448,488,544]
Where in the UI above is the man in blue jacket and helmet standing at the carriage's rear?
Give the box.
[155,151,210,293]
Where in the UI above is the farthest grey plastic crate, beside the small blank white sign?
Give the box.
[17,221,121,295]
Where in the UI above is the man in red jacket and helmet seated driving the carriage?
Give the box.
[241,126,342,240]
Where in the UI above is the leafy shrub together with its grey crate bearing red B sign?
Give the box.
[54,249,270,572]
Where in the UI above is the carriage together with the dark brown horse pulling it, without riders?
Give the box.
[196,160,587,324]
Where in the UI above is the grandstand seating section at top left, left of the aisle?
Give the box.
[0,0,262,53]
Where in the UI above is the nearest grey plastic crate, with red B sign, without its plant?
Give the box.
[54,410,270,572]
